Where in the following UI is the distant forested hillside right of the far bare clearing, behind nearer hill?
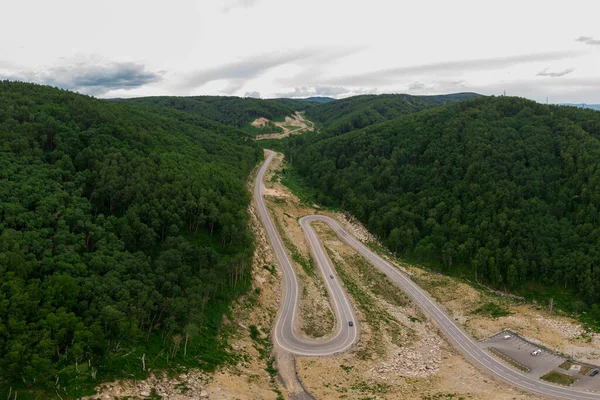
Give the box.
[306,93,479,135]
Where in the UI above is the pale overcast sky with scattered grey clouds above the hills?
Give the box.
[0,0,600,103]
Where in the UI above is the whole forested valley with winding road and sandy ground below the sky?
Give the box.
[0,83,600,400]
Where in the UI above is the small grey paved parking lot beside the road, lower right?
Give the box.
[481,331,600,392]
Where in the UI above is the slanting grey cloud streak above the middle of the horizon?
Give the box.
[180,47,361,94]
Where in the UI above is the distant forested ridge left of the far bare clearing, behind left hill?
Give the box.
[118,96,317,134]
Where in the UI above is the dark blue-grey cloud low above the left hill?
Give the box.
[4,60,162,95]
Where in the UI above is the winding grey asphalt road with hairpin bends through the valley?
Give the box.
[254,150,600,400]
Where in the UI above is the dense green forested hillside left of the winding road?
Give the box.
[0,81,262,397]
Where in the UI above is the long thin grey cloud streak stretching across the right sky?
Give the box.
[322,51,582,86]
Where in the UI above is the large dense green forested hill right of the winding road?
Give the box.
[285,97,600,312]
